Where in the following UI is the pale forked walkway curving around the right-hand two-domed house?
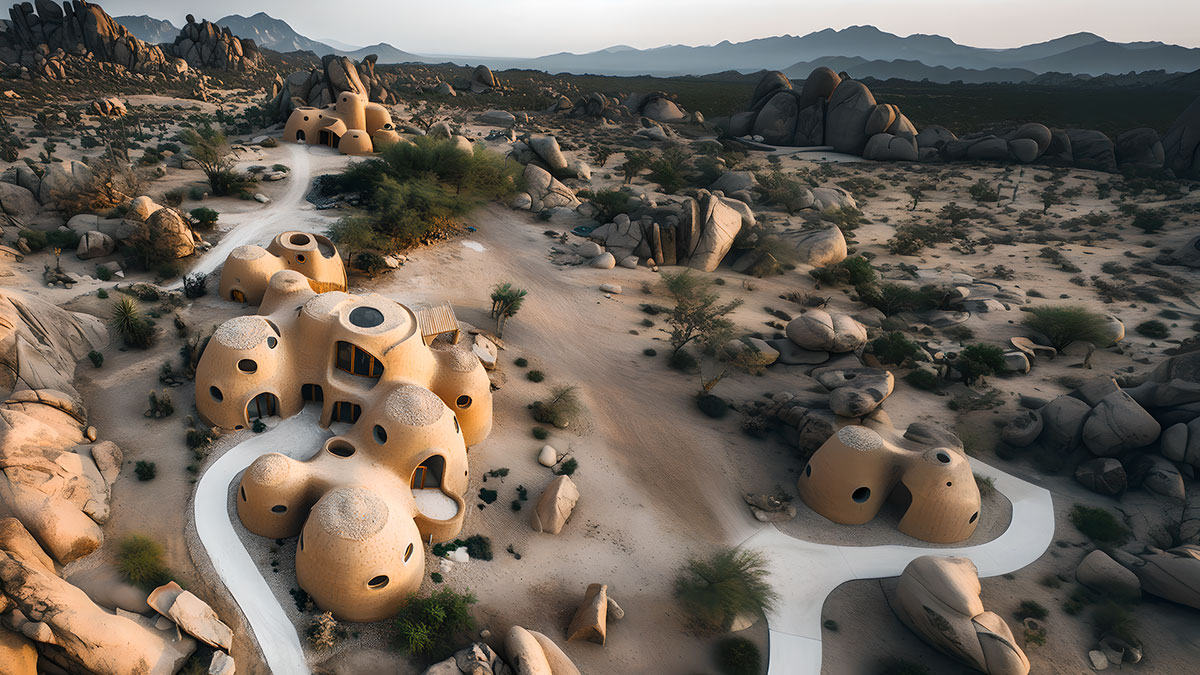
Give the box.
[743,459,1055,675]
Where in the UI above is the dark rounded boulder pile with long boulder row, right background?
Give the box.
[716,66,1200,177]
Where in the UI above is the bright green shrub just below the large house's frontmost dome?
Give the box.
[395,586,475,656]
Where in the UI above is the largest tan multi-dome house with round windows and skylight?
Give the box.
[196,270,492,621]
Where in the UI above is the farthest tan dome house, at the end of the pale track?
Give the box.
[283,91,400,155]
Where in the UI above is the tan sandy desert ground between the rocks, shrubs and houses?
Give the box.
[0,84,1200,675]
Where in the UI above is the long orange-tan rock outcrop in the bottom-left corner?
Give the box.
[0,518,196,675]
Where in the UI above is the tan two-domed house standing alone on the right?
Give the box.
[797,425,980,544]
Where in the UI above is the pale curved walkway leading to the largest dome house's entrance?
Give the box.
[192,410,320,675]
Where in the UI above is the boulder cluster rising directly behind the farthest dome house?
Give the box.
[266,54,395,120]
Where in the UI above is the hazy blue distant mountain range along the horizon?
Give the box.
[118,12,1200,83]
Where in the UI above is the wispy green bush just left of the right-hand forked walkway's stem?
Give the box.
[674,546,778,631]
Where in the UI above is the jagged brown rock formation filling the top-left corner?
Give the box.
[0,0,187,79]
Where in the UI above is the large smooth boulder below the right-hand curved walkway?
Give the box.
[888,556,1030,675]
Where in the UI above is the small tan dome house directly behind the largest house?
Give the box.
[218,231,347,305]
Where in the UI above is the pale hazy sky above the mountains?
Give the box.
[98,0,1200,56]
